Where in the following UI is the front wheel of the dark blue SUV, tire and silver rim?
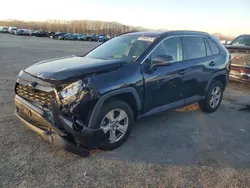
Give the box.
[91,100,134,150]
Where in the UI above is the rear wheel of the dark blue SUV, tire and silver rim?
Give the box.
[199,81,224,113]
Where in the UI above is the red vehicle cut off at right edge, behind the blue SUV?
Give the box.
[226,34,250,83]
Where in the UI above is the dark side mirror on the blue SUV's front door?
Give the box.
[149,55,173,71]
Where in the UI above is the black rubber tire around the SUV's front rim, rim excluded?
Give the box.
[91,99,134,150]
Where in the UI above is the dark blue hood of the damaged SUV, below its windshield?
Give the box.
[25,56,127,81]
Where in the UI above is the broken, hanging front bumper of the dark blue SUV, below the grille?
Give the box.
[15,95,108,157]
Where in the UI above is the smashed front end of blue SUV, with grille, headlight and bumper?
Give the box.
[15,71,108,156]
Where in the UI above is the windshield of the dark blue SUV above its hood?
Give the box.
[86,35,155,60]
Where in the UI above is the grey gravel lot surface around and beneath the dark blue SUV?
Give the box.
[0,34,250,188]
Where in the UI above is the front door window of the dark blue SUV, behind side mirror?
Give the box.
[151,37,183,62]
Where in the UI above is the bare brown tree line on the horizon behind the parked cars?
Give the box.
[0,20,146,35]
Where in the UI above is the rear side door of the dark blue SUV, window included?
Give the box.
[181,36,216,104]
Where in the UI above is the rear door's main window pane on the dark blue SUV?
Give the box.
[183,36,206,60]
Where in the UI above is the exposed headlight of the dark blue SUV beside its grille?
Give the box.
[59,80,86,103]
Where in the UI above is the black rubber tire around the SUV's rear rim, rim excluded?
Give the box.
[199,81,224,113]
